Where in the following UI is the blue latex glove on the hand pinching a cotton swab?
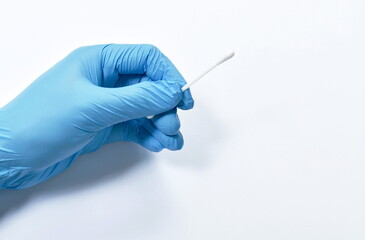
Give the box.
[0,44,194,189]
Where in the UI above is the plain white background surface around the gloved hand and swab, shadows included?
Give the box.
[0,0,365,240]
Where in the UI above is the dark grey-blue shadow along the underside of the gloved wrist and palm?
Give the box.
[0,142,150,222]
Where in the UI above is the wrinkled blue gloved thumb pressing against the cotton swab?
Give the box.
[83,80,182,131]
